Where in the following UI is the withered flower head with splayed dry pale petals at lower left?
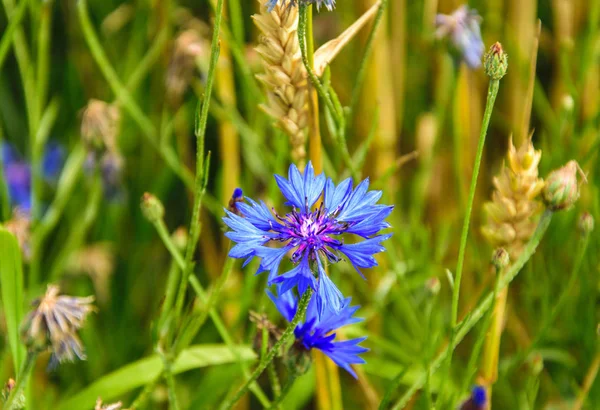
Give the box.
[21,285,94,368]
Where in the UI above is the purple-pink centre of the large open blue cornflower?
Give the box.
[273,203,349,263]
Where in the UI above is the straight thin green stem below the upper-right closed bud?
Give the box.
[442,80,500,394]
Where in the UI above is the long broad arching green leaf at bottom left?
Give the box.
[57,345,256,410]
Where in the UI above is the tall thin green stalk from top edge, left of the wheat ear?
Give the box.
[175,0,224,315]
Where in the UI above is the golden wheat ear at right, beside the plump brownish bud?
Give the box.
[482,138,544,260]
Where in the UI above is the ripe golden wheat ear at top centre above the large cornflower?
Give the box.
[252,0,308,166]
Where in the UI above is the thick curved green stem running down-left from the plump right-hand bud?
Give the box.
[390,210,554,410]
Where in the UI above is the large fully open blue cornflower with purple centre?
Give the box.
[223,162,393,312]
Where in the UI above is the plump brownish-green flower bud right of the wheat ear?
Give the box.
[544,161,579,211]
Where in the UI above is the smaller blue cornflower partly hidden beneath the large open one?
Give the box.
[267,290,369,378]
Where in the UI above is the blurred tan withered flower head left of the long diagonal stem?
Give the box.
[81,99,121,153]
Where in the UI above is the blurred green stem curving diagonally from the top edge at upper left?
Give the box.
[77,0,194,189]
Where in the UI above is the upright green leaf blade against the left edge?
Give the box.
[0,227,25,369]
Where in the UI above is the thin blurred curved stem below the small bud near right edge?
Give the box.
[502,231,590,372]
